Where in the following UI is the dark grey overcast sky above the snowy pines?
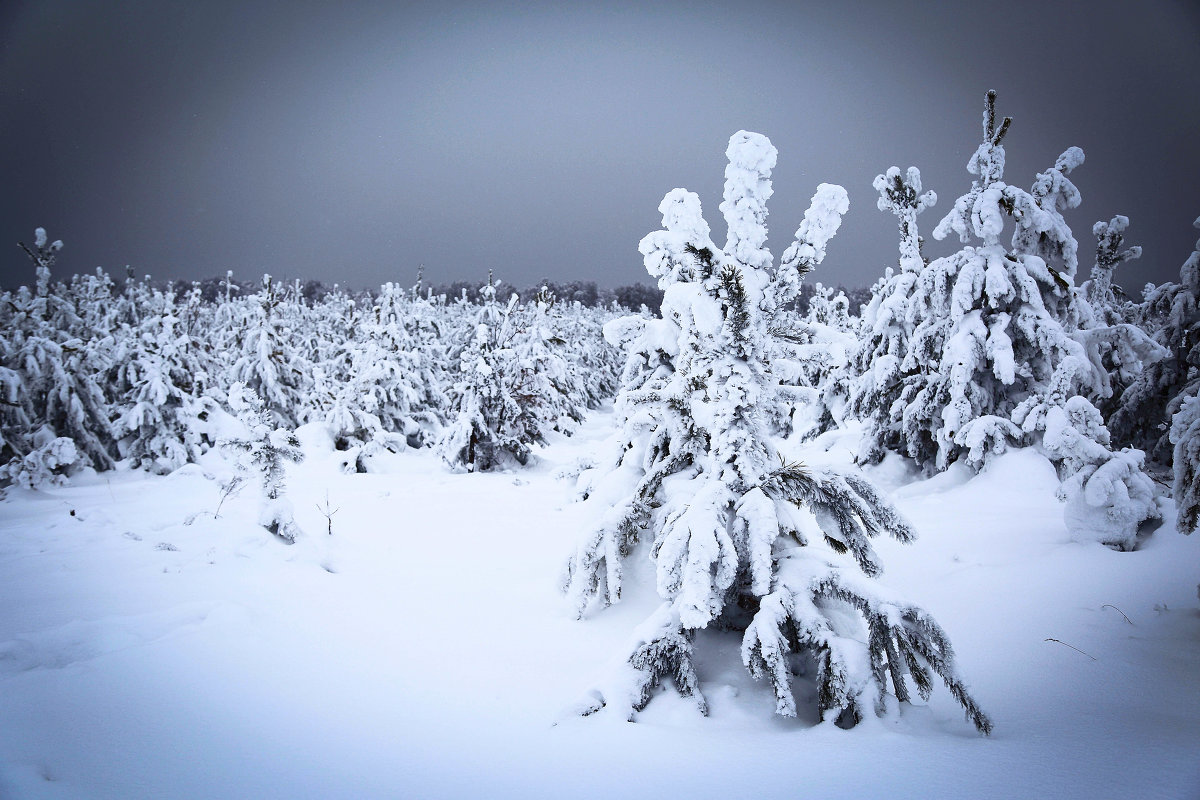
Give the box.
[0,0,1200,289]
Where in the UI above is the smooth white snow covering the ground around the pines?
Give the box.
[0,414,1200,800]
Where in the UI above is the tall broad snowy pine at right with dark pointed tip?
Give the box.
[860,92,1157,548]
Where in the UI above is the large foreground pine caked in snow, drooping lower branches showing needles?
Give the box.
[563,131,991,733]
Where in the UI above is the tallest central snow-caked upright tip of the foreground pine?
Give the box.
[720,131,778,270]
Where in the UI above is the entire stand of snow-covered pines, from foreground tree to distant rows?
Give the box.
[0,92,1200,732]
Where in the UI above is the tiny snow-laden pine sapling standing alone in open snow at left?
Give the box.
[221,383,304,545]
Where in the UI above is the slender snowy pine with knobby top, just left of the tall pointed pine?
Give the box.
[850,167,937,463]
